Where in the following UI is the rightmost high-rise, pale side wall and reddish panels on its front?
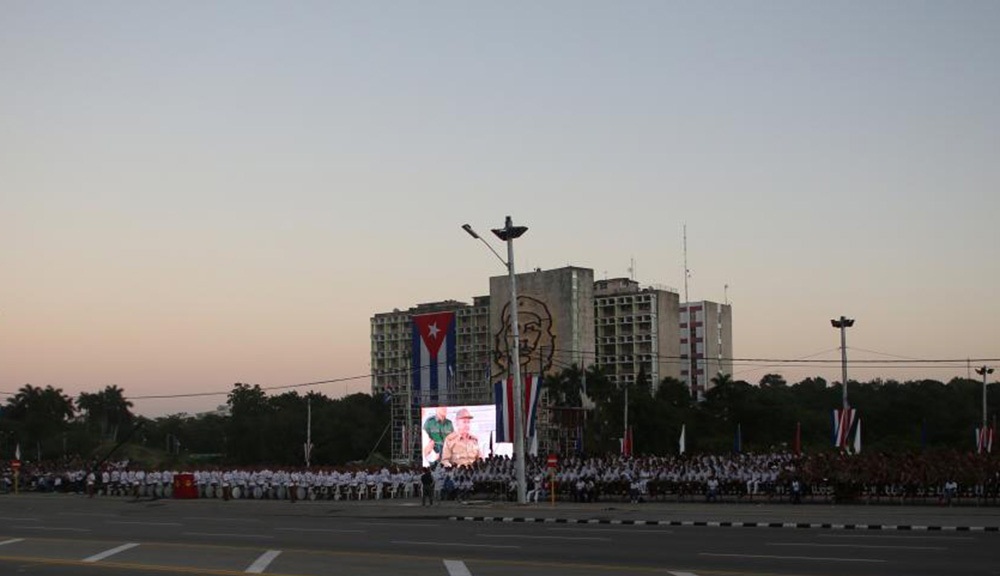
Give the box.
[679,300,733,399]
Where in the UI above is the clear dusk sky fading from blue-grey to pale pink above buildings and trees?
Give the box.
[0,0,1000,417]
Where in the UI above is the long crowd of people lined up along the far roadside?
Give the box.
[0,452,1000,504]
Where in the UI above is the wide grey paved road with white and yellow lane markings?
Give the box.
[0,494,1000,576]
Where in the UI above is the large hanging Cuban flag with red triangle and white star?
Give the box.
[411,312,457,406]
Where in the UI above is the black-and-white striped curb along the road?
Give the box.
[448,516,1000,532]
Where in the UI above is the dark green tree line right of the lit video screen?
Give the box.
[560,367,1000,455]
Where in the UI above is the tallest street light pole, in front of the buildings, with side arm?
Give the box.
[462,216,528,504]
